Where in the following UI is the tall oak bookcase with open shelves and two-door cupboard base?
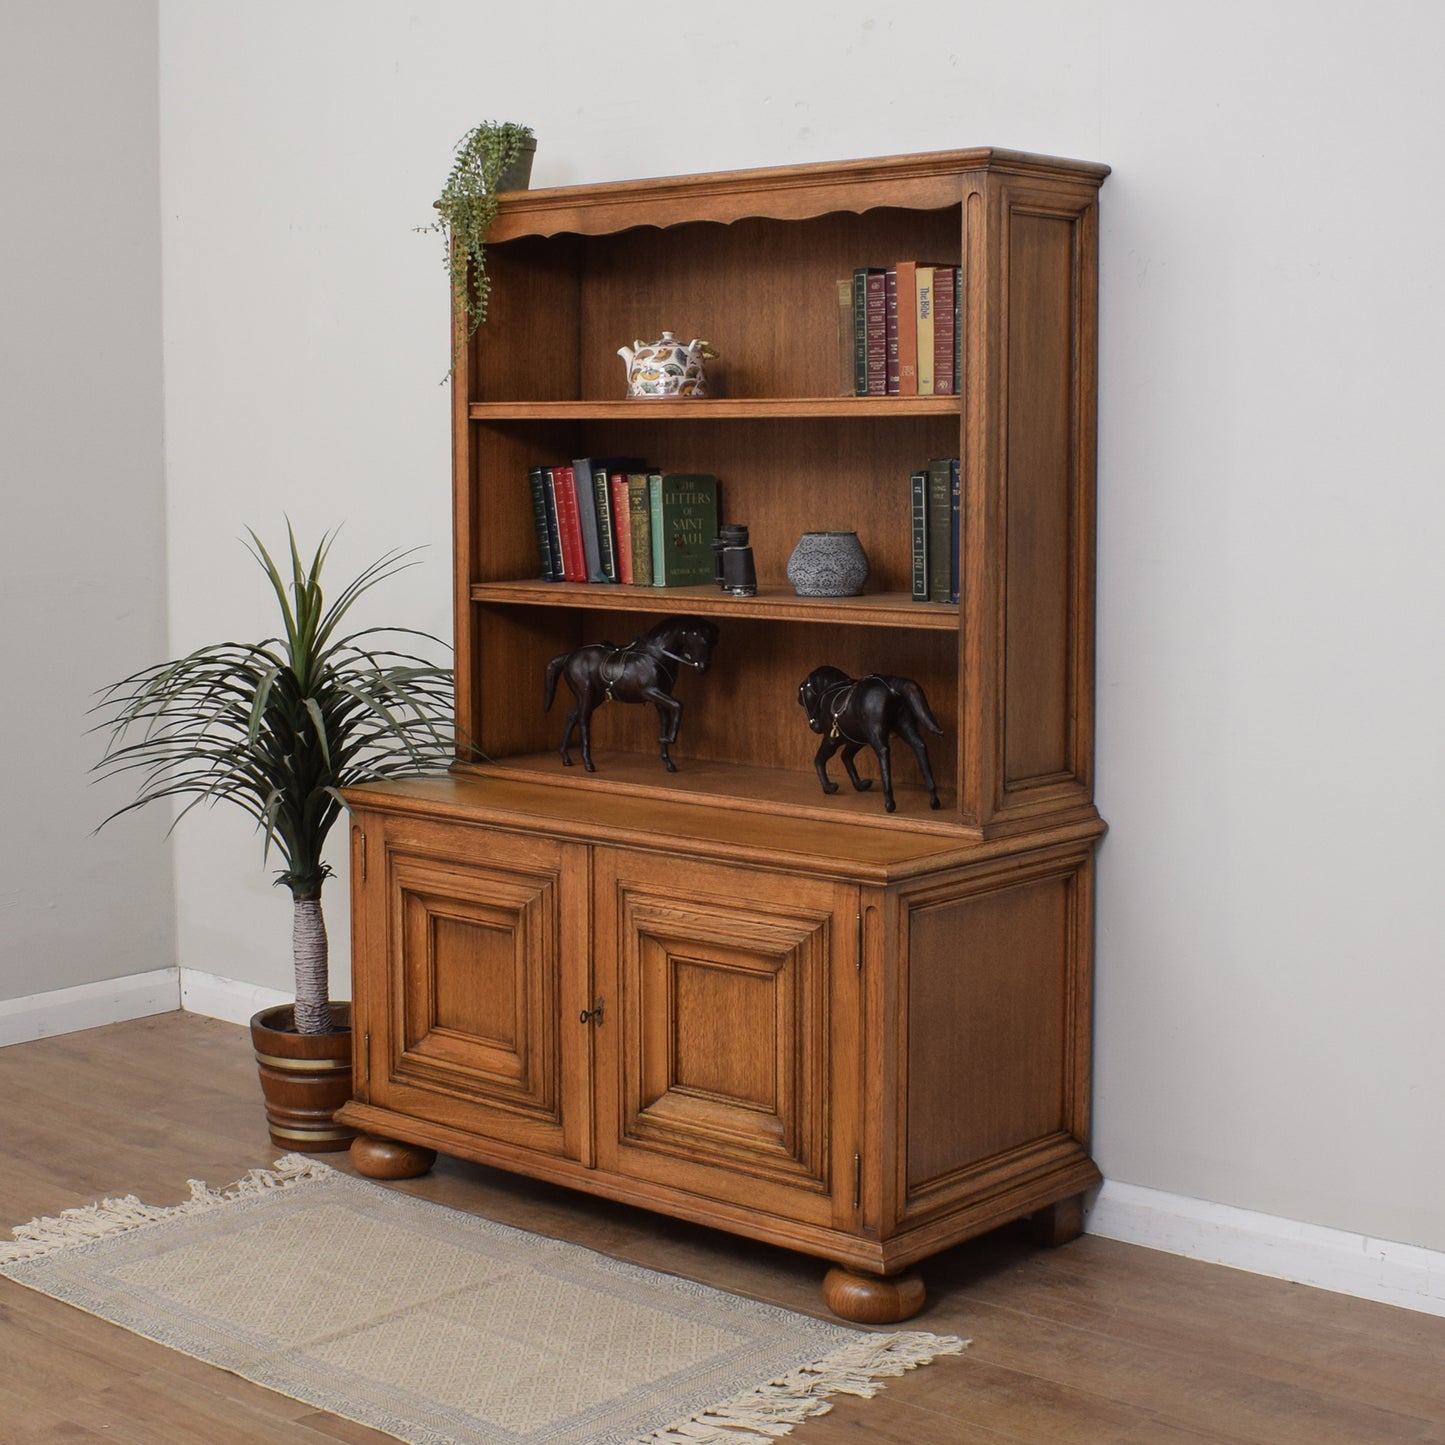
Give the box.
[338,149,1108,1322]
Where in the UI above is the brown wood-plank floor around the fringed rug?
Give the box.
[0,1014,1445,1445]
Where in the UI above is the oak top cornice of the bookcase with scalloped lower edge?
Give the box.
[488,147,1108,241]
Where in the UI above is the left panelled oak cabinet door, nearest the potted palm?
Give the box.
[353,812,591,1163]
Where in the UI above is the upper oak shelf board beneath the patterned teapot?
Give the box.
[467,396,959,422]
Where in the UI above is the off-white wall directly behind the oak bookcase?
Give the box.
[149,0,1445,1248]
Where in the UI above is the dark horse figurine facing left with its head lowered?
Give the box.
[798,668,944,812]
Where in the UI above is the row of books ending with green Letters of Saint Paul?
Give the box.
[527,457,718,587]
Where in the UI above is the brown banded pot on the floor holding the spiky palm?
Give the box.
[251,1003,355,1155]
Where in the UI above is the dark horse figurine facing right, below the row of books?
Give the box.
[545,617,718,773]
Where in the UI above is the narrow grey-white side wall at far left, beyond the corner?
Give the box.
[0,0,175,1000]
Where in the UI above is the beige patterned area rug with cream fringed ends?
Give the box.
[8,1155,962,1445]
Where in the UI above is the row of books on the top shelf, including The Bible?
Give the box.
[840,262,962,396]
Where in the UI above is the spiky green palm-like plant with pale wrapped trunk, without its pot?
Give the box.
[94,523,455,1033]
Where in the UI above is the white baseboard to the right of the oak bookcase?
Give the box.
[1084,1181,1445,1315]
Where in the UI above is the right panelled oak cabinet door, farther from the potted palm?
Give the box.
[594,848,858,1228]
